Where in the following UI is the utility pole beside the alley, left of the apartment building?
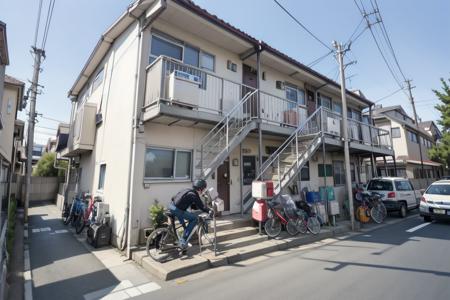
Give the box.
[24,47,45,223]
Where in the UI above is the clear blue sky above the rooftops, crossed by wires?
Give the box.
[0,0,450,143]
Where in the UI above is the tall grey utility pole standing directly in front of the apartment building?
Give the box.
[333,41,355,231]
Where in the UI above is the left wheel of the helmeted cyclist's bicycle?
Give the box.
[145,227,177,262]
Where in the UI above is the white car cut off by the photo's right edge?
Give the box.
[420,180,450,222]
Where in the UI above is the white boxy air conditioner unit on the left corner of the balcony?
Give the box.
[168,70,201,107]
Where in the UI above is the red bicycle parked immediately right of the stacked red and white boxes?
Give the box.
[264,200,298,238]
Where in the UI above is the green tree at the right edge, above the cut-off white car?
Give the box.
[429,78,450,169]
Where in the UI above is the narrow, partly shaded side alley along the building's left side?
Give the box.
[25,203,163,300]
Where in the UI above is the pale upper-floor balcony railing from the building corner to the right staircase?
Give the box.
[144,56,307,127]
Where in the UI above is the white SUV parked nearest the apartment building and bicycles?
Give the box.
[367,177,420,218]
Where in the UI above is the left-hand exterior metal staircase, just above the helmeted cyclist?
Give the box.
[195,90,258,179]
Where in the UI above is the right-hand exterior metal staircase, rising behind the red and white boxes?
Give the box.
[243,107,325,212]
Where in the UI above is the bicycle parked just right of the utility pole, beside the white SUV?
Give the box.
[355,192,387,224]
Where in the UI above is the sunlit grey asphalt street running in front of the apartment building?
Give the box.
[143,216,450,300]
